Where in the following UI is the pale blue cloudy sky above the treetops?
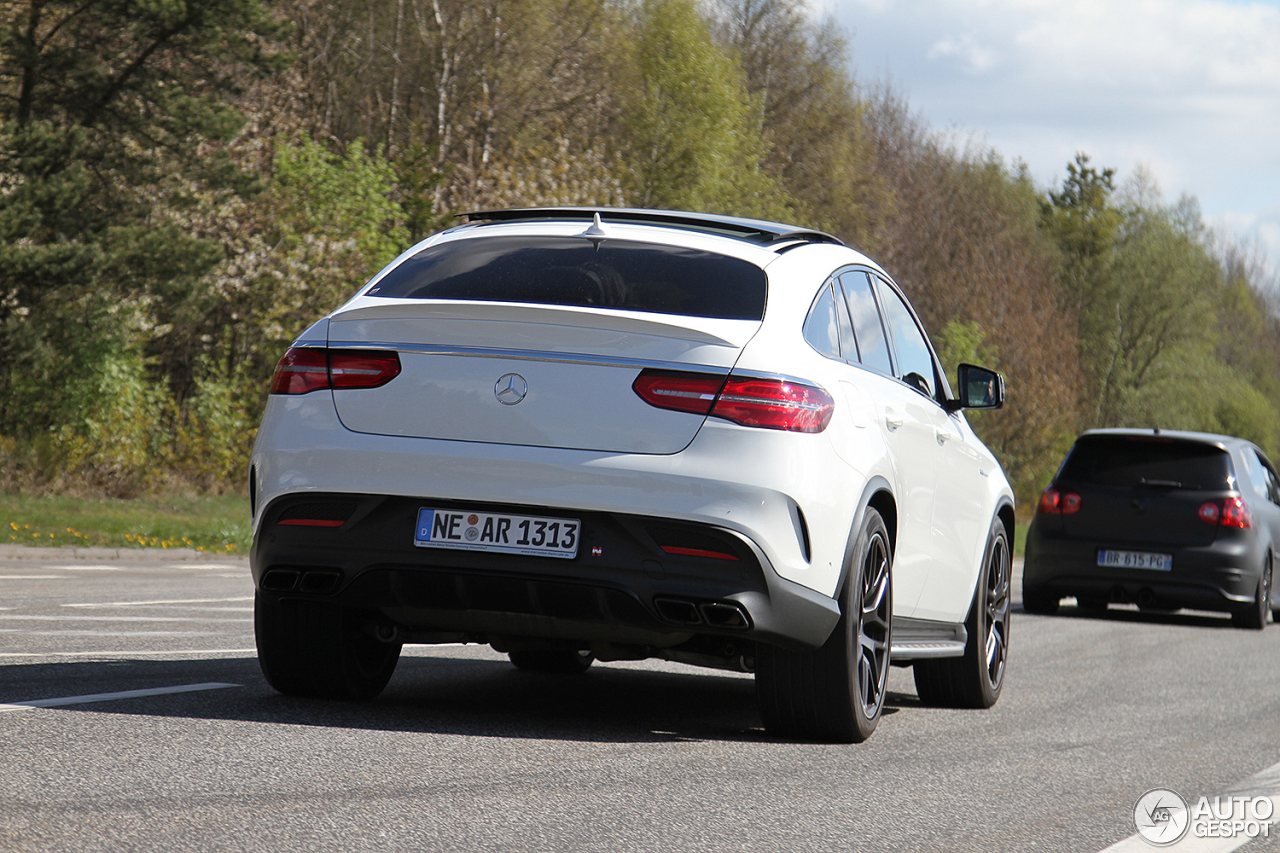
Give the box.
[810,0,1280,270]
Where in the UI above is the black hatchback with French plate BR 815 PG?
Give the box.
[1023,429,1280,630]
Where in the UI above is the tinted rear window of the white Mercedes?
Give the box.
[369,236,765,320]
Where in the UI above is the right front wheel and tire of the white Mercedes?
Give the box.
[911,517,1011,708]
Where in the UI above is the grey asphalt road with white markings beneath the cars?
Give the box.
[0,551,1280,853]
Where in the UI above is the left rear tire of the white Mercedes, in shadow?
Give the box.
[253,593,401,699]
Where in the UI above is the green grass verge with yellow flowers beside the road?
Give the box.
[0,493,251,553]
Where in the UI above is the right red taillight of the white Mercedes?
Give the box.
[631,370,836,433]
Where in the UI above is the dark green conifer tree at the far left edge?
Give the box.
[0,0,275,488]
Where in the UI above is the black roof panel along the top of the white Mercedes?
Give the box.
[457,207,845,247]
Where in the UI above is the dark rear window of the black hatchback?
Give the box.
[1057,435,1233,489]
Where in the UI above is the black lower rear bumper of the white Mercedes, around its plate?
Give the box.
[251,492,840,649]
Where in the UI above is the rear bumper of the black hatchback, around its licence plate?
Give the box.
[1023,525,1265,612]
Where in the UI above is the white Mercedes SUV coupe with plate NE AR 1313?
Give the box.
[250,207,1014,742]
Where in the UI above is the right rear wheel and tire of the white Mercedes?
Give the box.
[755,507,893,743]
